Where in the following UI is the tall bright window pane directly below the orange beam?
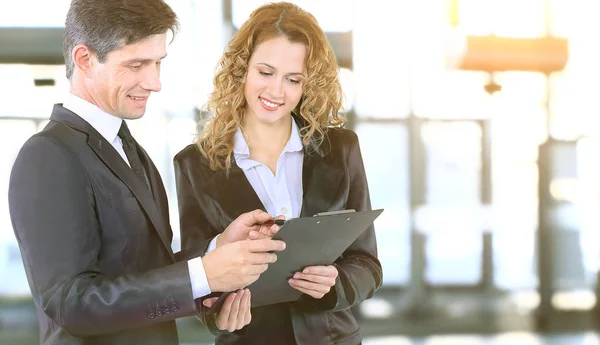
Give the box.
[491,79,547,289]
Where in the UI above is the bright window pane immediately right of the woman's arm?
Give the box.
[356,123,410,285]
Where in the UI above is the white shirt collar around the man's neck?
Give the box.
[63,92,123,143]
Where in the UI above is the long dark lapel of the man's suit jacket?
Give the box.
[51,105,175,261]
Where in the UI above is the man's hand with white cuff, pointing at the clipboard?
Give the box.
[202,239,285,292]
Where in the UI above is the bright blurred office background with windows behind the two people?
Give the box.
[0,0,600,345]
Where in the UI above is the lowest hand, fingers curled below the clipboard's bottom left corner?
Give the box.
[202,289,252,332]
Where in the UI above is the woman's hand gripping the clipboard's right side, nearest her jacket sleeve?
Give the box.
[288,266,338,299]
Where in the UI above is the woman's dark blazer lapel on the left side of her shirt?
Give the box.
[205,163,266,222]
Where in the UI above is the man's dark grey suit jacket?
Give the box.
[9,104,196,345]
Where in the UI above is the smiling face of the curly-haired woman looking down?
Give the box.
[244,36,306,124]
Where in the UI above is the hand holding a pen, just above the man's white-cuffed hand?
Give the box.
[217,210,279,248]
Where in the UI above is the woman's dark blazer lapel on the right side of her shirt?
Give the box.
[300,136,344,217]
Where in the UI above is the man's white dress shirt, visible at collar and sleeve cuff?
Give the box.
[63,93,211,299]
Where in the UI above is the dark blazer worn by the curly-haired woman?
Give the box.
[174,125,382,345]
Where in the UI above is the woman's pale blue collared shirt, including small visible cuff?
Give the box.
[207,120,304,252]
